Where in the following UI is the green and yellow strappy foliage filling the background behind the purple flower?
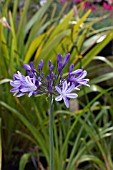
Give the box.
[0,0,113,170]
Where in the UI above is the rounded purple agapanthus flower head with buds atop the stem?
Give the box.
[10,54,89,108]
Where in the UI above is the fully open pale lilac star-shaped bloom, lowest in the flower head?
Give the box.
[55,81,78,108]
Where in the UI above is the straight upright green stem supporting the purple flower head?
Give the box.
[49,95,54,170]
